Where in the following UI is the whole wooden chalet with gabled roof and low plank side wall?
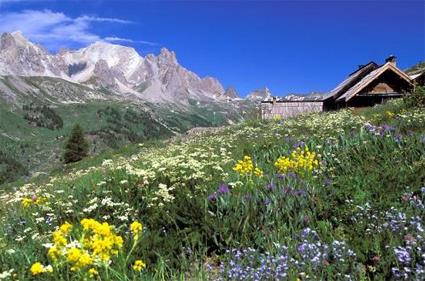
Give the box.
[261,56,414,119]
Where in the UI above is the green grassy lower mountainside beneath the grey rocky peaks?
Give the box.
[0,95,250,184]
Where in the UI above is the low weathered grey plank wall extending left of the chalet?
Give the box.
[261,101,323,119]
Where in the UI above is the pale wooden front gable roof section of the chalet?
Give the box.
[337,62,412,101]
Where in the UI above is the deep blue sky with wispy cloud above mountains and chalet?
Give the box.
[0,0,425,95]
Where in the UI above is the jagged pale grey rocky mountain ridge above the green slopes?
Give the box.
[0,32,226,103]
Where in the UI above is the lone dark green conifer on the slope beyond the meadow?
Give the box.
[63,124,89,163]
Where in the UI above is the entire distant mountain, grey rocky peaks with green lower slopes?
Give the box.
[0,32,255,184]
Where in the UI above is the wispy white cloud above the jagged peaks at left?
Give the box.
[0,9,155,50]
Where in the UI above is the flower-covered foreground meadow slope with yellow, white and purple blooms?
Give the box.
[0,97,425,280]
